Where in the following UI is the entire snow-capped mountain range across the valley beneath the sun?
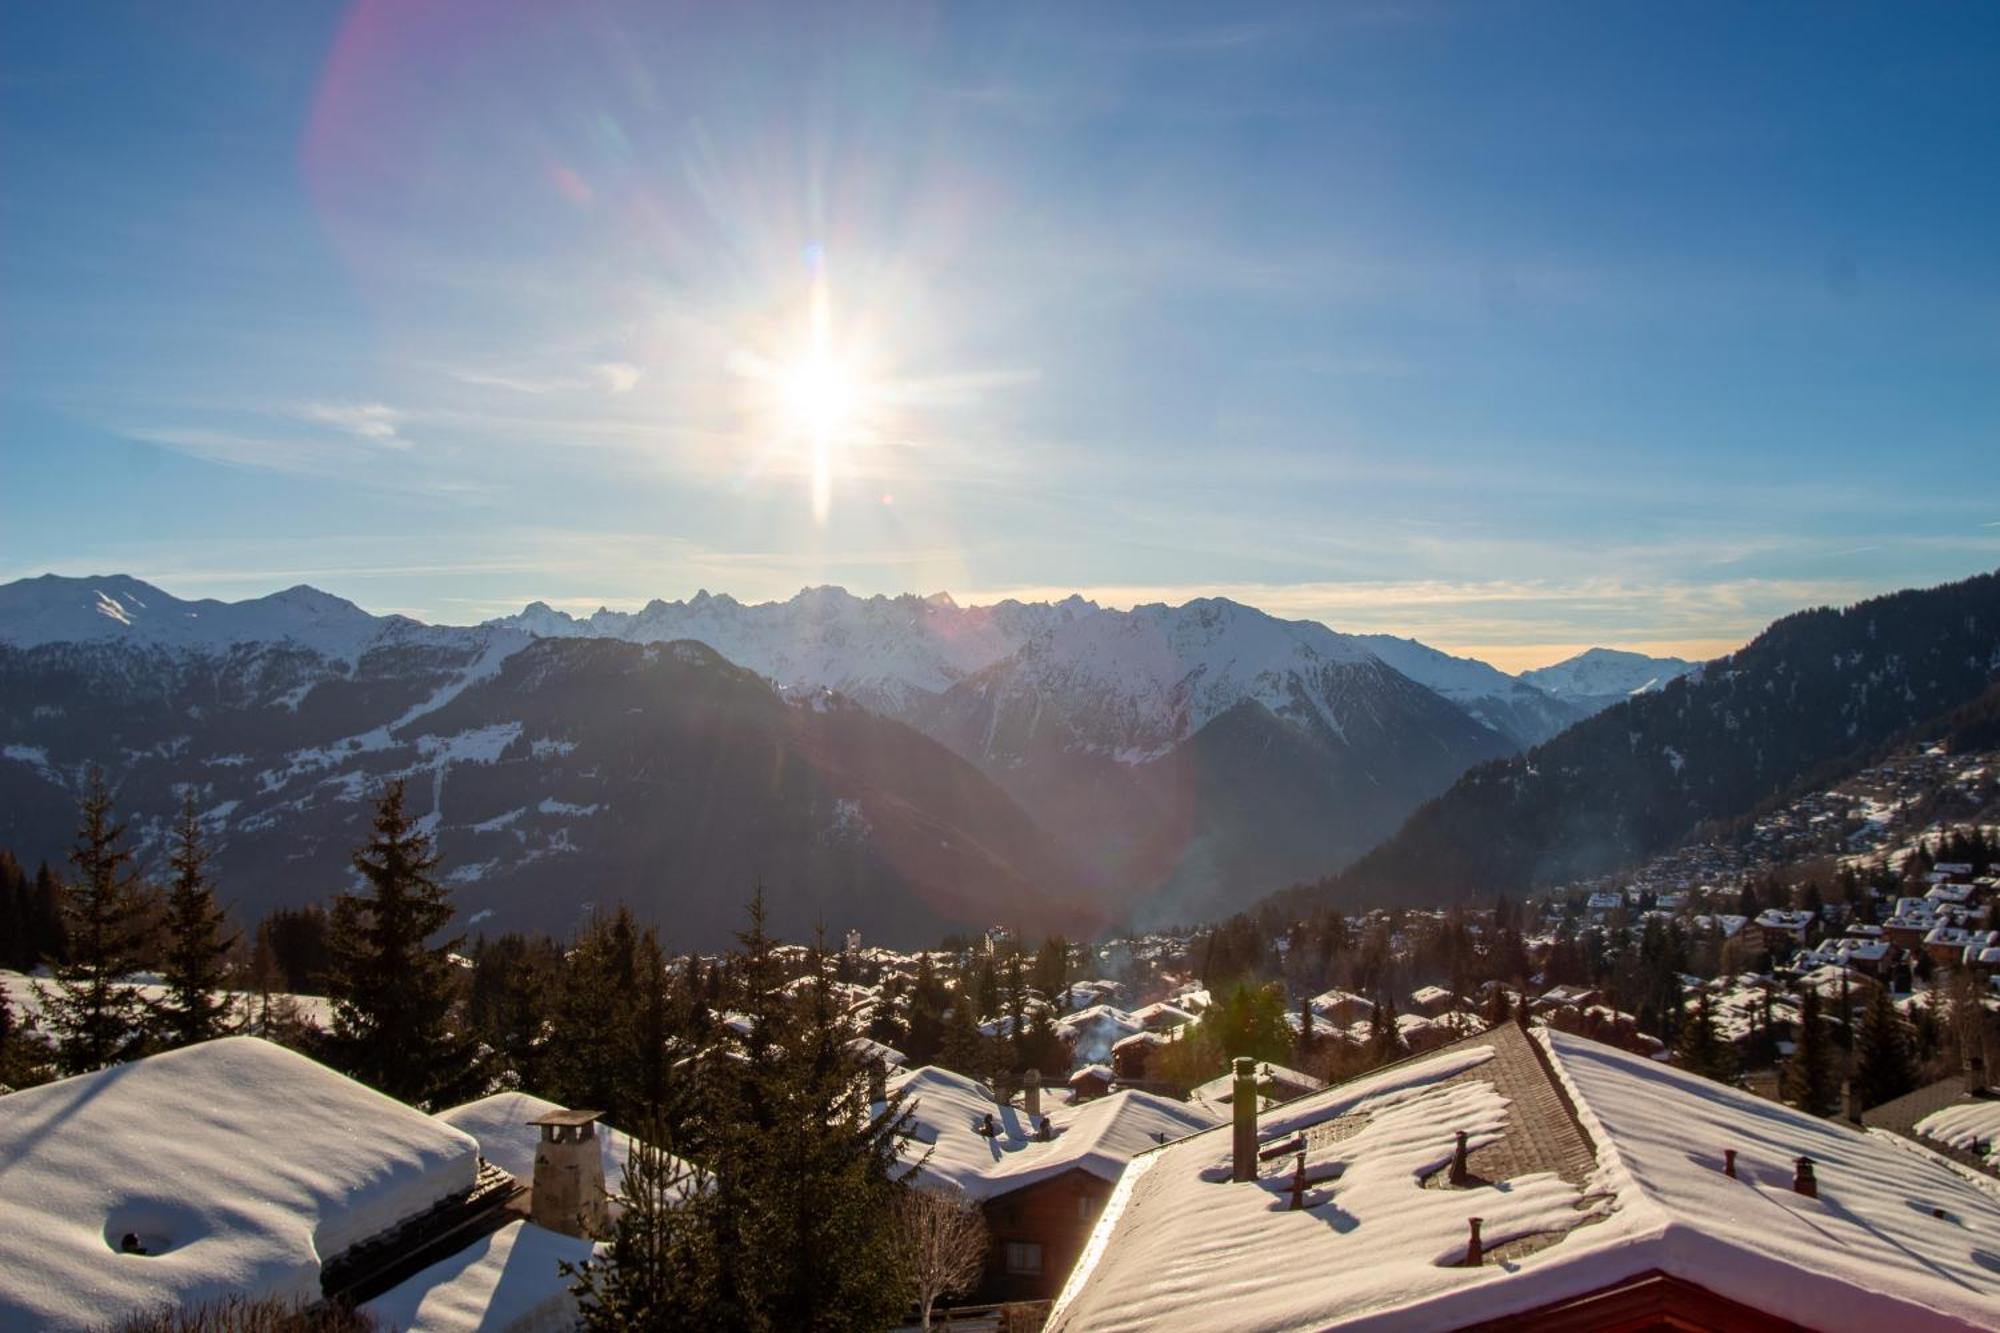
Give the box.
[0,574,1686,945]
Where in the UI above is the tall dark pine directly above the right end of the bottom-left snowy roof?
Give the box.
[328,781,480,1109]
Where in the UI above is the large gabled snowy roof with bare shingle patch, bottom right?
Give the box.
[1050,1025,2000,1331]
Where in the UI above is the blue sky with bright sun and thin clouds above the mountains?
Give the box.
[0,0,2000,667]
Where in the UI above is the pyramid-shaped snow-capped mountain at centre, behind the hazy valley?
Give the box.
[912,598,1516,923]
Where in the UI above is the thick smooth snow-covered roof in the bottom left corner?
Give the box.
[0,1037,478,1329]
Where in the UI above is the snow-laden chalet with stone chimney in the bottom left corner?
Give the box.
[0,1037,608,1333]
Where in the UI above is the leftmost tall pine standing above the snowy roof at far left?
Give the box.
[44,773,146,1075]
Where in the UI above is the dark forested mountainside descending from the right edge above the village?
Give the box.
[1278,572,2000,911]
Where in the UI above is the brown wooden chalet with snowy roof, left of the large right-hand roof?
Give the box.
[888,1065,1222,1301]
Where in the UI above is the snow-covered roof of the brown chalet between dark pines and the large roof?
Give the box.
[888,1065,1220,1199]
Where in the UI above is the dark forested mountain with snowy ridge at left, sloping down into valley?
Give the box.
[0,578,1102,947]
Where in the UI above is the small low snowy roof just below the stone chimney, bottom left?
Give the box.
[362,1221,594,1333]
